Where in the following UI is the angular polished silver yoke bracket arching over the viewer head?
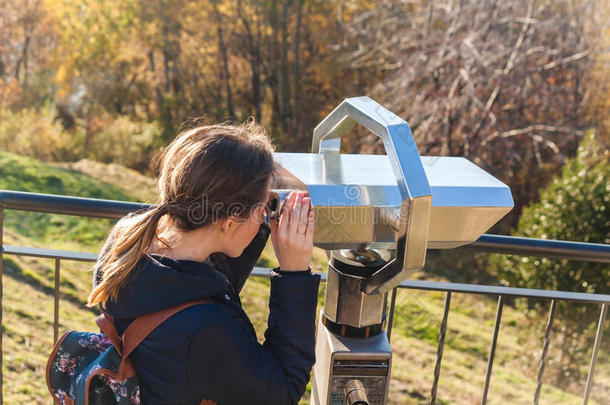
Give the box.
[312,97,432,294]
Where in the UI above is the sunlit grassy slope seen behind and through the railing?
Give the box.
[0,153,610,404]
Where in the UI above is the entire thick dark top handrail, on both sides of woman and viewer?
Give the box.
[0,190,610,263]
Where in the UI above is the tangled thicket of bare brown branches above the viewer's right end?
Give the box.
[343,0,599,226]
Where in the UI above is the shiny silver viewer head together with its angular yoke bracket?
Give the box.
[274,97,513,294]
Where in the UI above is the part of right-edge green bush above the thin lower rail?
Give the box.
[491,134,610,293]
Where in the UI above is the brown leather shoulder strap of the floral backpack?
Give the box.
[96,300,213,380]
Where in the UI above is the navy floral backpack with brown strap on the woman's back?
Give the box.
[47,301,212,405]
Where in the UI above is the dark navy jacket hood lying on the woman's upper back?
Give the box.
[104,254,233,319]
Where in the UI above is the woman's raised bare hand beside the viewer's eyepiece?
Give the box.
[270,191,314,271]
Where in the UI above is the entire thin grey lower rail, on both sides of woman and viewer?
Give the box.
[3,245,610,304]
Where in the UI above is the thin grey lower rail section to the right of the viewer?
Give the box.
[398,280,610,304]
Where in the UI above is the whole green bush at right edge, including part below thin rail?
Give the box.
[490,134,610,384]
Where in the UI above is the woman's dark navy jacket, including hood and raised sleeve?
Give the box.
[95,226,320,405]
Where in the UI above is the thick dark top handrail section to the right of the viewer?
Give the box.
[458,234,610,263]
